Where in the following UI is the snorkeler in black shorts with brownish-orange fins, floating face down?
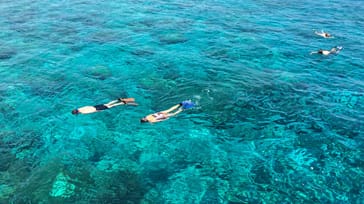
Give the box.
[72,98,138,115]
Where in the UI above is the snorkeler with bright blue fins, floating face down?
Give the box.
[140,101,195,123]
